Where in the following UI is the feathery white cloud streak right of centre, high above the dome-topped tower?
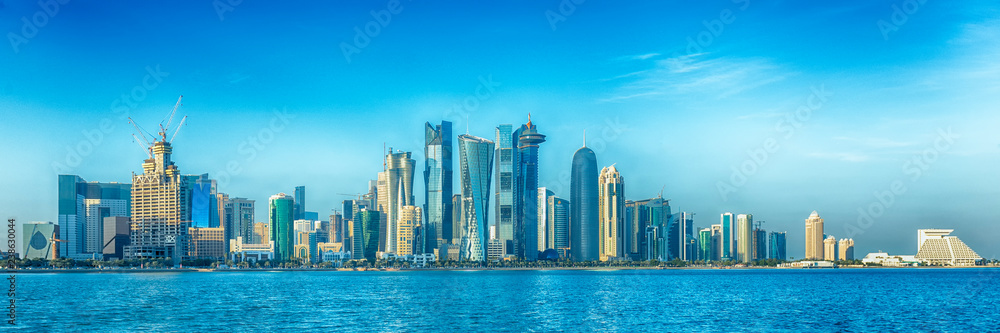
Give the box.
[601,53,791,102]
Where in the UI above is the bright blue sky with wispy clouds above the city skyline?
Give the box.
[0,0,1000,258]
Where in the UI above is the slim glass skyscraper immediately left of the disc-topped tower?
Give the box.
[493,124,518,254]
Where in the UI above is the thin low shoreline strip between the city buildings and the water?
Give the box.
[6,266,1000,274]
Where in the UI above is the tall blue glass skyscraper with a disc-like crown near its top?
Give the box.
[514,115,545,260]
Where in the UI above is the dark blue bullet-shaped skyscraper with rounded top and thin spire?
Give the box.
[569,139,600,261]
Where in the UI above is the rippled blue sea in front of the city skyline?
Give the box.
[6,268,1000,332]
